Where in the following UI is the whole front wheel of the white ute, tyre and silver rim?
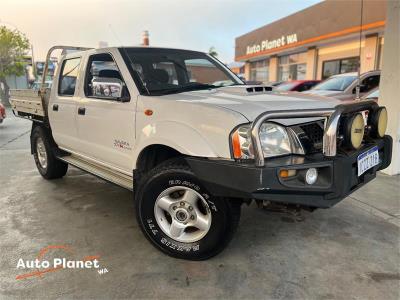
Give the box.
[135,159,241,260]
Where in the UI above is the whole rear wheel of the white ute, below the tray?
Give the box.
[31,126,68,179]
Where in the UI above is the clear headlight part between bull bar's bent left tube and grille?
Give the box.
[259,123,292,157]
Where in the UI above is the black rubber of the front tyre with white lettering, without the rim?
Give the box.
[136,170,230,260]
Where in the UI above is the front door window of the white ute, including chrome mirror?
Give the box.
[84,53,129,101]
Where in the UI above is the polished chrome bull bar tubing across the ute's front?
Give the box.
[251,101,378,167]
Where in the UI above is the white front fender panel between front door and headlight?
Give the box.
[134,95,248,168]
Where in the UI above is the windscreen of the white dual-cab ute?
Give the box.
[120,48,243,95]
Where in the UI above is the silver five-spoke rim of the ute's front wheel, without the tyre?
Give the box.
[154,186,211,243]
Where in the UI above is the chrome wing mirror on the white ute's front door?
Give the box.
[92,77,130,102]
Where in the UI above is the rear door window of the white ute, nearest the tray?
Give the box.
[58,58,81,96]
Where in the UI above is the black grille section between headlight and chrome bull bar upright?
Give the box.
[292,121,324,154]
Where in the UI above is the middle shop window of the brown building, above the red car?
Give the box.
[278,52,307,81]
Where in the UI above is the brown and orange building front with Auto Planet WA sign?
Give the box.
[235,0,386,82]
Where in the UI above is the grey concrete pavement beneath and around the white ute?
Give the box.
[0,112,400,300]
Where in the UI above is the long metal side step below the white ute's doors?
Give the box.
[57,154,133,191]
